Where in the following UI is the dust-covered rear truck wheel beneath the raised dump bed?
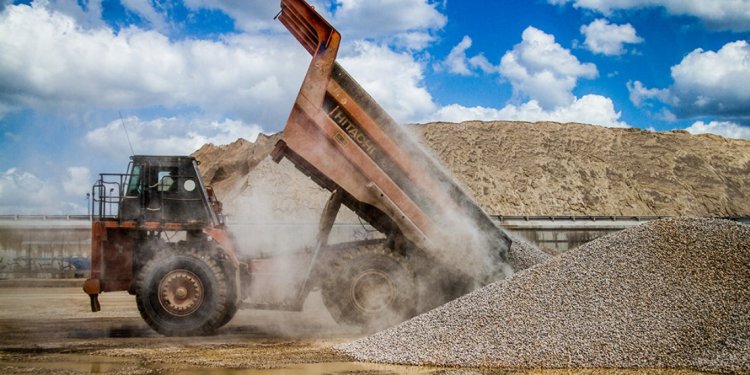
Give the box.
[322,245,417,331]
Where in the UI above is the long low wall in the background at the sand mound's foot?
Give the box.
[5,215,716,280]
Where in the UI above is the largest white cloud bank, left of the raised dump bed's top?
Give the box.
[0,3,309,126]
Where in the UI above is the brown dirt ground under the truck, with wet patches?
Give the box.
[0,281,716,375]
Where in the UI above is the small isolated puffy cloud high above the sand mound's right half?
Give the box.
[581,18,643,56]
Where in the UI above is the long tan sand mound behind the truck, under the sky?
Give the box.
[195,121,750,216]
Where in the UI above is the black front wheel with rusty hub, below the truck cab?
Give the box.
[135,250,231,336]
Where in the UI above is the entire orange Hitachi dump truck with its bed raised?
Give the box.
[84,0,512,336]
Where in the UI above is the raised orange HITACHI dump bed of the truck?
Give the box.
[273,0,511,279]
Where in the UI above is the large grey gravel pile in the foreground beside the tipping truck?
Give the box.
[335,219,750,372]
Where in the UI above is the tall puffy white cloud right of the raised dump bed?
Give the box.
[499,26,598,109]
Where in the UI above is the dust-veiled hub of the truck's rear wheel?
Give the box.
[351,270,396,313]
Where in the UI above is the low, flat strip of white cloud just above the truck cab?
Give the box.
[84,117,262,160]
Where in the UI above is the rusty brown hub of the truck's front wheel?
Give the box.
[159,270,205,316]
